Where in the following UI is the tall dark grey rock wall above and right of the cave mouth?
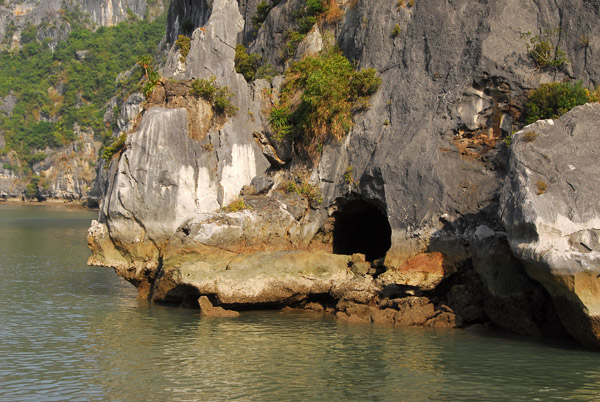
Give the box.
[323,0,600,259]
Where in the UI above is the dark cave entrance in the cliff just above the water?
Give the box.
[333,200,392,261]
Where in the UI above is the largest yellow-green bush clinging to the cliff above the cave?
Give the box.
[269,49,381,153]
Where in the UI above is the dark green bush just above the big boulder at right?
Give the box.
[525,81,598,124]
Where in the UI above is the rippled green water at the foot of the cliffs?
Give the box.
[0,204,600,401]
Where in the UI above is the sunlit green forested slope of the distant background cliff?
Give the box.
[0,15,166,171]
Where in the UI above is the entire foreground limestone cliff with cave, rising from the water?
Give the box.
[88,0,600,347]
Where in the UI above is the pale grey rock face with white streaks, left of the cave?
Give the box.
[95,0,269,266]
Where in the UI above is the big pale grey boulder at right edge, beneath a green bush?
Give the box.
[501,104,600,346]
